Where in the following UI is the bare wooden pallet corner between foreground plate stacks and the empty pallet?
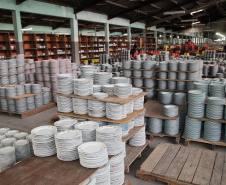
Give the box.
[124,140,150,173]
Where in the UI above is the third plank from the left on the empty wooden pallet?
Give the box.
[165,146,190,179]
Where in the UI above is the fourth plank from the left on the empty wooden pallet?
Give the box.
[178,148,202,183]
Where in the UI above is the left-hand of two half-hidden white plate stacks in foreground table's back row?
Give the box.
[54,119,78,132]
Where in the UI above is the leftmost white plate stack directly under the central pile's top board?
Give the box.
[57,96,73,112]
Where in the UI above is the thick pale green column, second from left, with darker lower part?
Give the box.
[70,15,80,65]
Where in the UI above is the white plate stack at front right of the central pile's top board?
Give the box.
[114,83,132,98]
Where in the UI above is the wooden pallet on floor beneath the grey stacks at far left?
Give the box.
[0,103,56,119]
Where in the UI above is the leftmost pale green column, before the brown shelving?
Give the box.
[12,7,24,54]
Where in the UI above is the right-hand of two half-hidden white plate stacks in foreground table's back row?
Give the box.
[75,121,99,143]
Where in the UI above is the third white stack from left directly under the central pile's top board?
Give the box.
[88,100,106,117]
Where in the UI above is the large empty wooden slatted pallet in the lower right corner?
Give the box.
[136,143,226,185]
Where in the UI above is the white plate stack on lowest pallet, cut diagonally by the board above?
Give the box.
[129,127,146,146]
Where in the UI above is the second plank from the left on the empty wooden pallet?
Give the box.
[152,145,181,176]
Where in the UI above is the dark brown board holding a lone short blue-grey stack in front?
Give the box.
[144,100,187,120]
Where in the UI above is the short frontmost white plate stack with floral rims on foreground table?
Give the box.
[78,142,108,168]
